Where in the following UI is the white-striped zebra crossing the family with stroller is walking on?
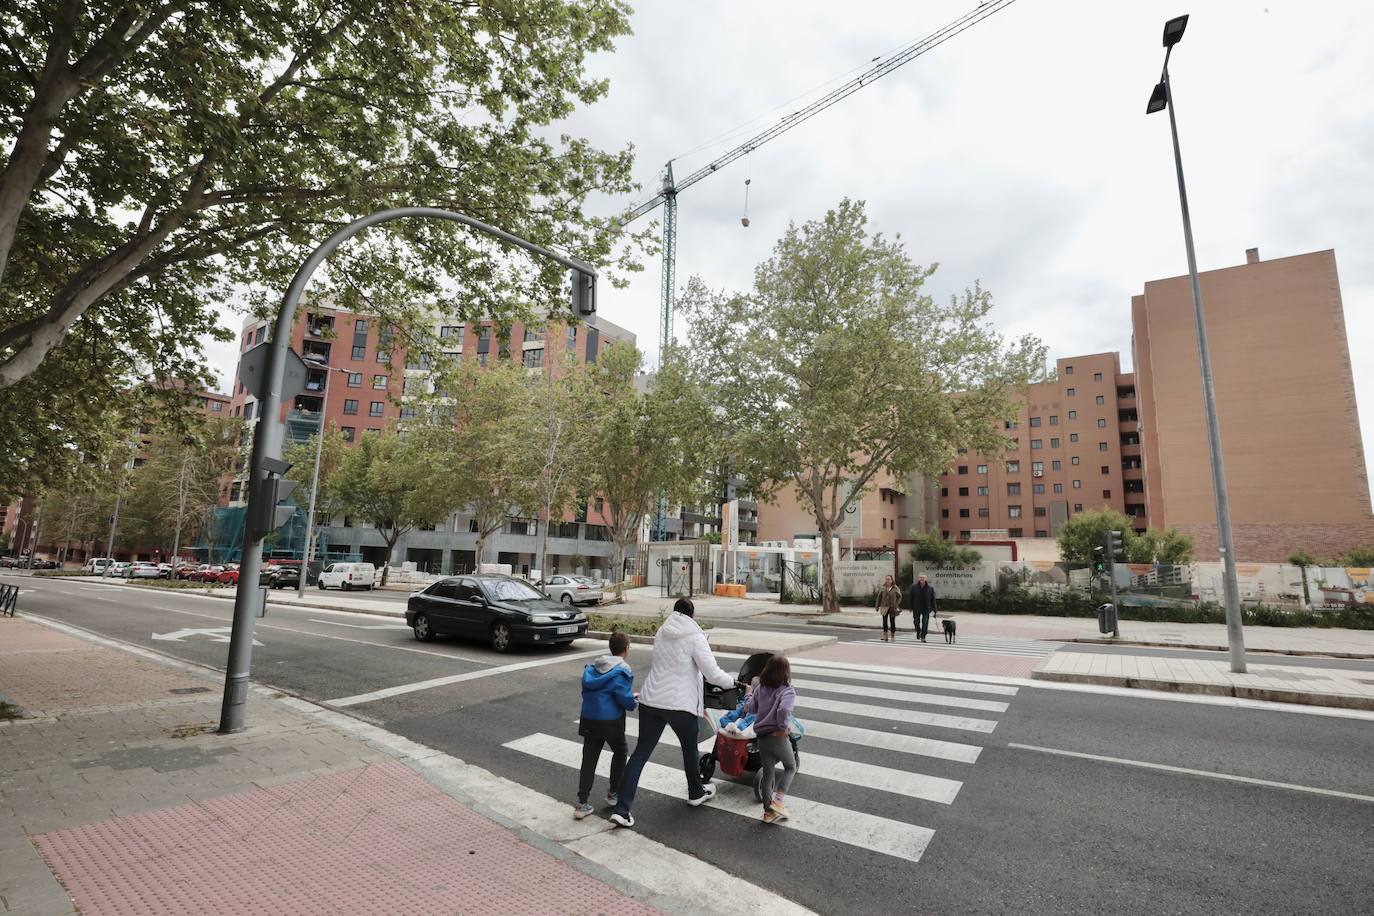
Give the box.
[504,658,1020,862]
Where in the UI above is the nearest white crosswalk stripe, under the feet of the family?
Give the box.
[504,733,934,862]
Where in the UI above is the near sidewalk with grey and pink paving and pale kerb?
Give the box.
[0,617,805,916]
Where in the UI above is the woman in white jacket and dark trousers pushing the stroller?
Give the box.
[610,597,735,827]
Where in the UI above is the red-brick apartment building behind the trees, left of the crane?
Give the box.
[228,306,635,574]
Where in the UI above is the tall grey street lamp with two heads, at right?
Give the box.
[1145,15,1245,674]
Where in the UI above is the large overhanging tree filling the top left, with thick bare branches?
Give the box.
[0,0,642,489]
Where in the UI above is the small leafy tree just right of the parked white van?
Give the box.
[328,433,453,585]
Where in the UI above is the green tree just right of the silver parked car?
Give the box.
[588,343,720,600]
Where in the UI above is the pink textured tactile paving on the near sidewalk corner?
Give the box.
[34,762,655,916]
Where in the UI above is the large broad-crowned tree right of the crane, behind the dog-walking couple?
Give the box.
[683,201,1044,611]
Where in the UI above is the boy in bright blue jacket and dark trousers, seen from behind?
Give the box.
[573,632,638,820]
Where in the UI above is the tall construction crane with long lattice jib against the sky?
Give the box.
[621,0,1015,365]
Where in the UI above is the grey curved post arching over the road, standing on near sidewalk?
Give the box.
[218,207,596,735]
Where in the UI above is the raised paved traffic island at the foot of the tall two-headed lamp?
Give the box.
[1032,652,1374,710]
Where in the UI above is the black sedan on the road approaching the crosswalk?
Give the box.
[405,575,587,652]
